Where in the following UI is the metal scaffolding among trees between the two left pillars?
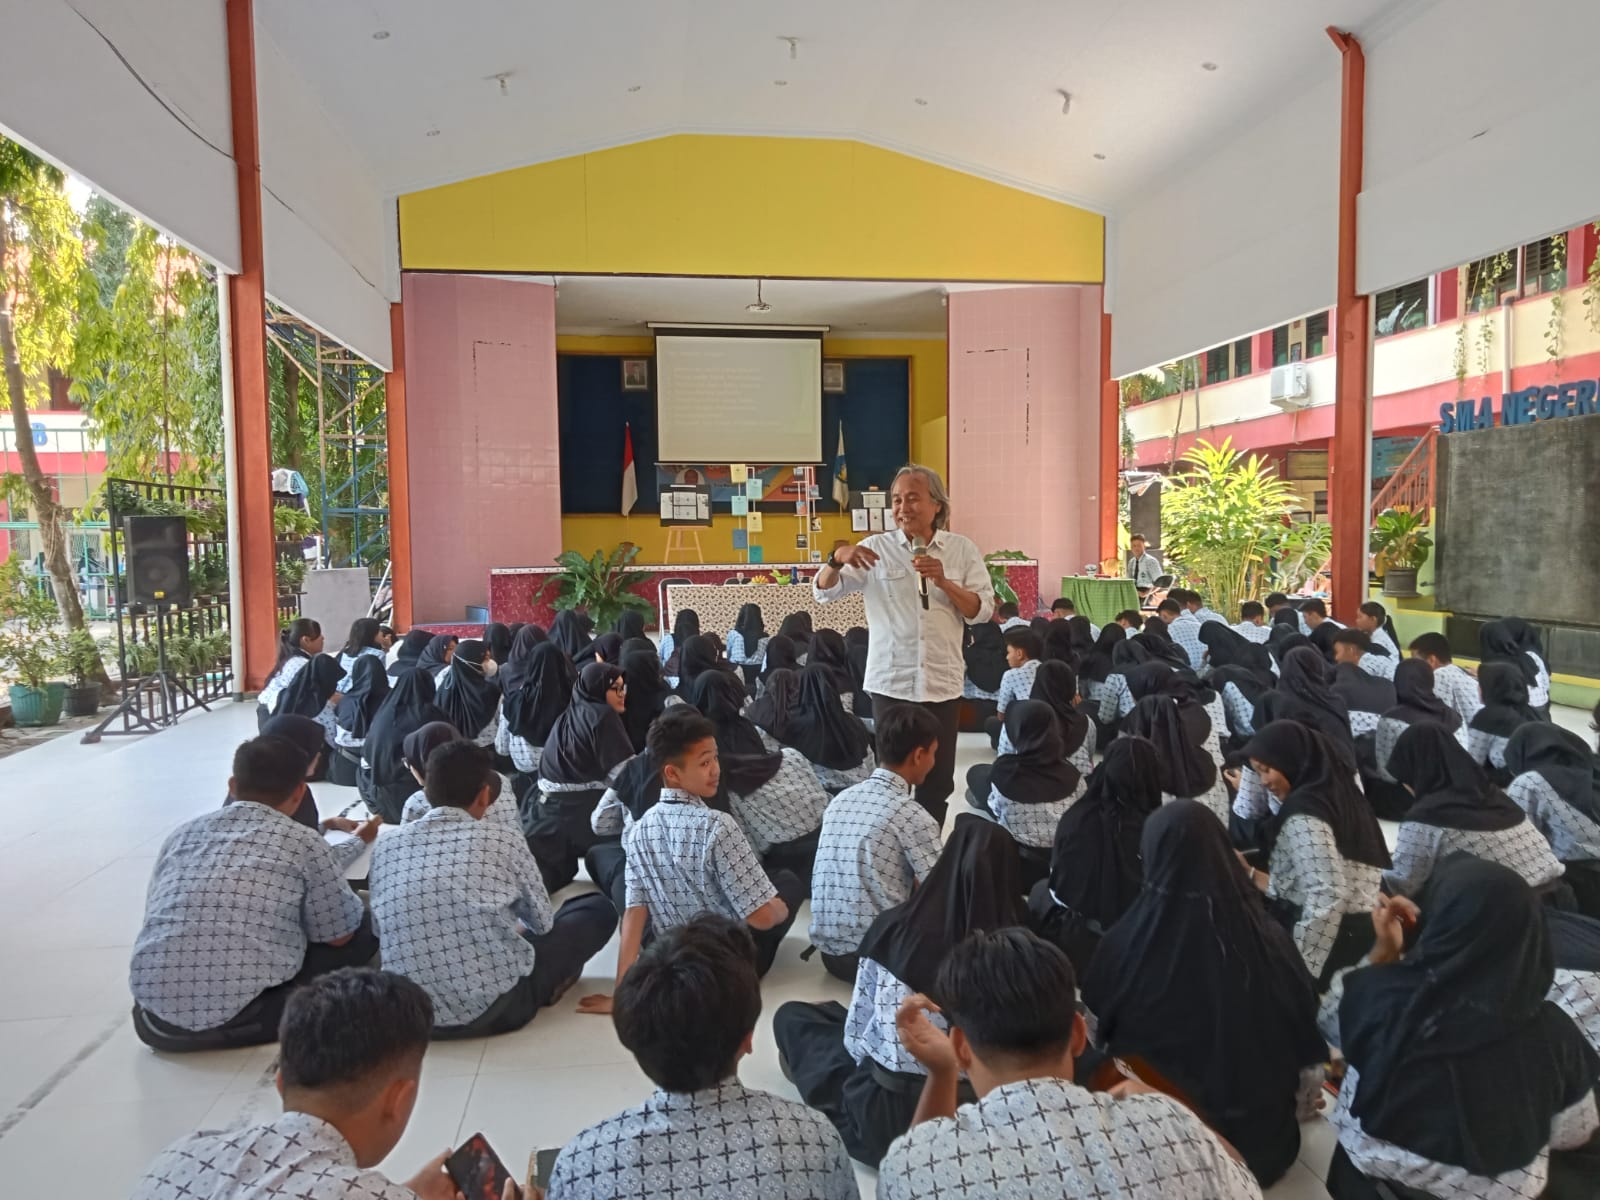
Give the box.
[267,309,389,568]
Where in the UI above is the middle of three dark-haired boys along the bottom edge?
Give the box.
[549,914,859,1200]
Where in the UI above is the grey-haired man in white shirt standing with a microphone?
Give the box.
[813,464,995,826]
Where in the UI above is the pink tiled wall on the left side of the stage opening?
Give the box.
[402,274,562,622]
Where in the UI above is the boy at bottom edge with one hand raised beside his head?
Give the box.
[878,930,1261,1200]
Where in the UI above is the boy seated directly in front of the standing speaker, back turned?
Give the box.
[811,704,941,982]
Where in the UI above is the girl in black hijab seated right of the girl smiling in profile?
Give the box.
[1384,725,1562,896]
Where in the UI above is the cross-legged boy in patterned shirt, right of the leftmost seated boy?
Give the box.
[371,739,616,1038]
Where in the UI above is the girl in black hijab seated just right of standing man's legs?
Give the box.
[978,699,1083,893]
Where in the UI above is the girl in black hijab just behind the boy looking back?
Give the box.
[690,670,827,896]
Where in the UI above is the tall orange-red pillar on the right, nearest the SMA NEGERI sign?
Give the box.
[1328,26,1373,621]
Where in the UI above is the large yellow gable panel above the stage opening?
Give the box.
[400,134,1104,283]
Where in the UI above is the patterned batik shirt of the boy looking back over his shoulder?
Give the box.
[622,787,778,933]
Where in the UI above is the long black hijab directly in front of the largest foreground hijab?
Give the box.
[1050,738,1162,930]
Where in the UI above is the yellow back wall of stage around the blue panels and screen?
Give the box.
[555,334,949,563]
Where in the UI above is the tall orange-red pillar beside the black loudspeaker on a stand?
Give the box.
[227,0,278,691]
